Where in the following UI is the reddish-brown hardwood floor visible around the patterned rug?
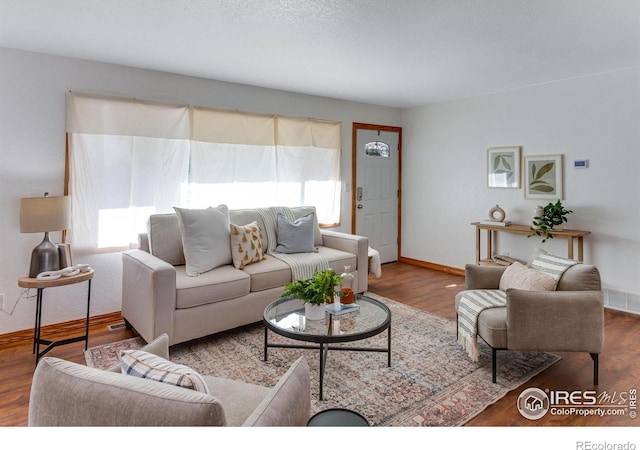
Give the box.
[0,263,640,427]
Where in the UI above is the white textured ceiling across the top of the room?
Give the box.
[0,0,640,107]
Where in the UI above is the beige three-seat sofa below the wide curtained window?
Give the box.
[122,207,369,345]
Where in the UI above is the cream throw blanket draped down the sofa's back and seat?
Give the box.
[258,206,329,281]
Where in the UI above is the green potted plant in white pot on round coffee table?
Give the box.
[280,269,342,320]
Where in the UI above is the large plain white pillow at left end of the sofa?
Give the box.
[173,205,233,277]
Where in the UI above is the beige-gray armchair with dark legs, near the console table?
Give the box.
[455,264,604,385]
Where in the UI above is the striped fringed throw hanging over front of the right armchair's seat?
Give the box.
[458,289,507,361]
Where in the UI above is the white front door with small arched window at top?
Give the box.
[353,124,400,263]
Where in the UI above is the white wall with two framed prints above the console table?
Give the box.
[401,68,640,307]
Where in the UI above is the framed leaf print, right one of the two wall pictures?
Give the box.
[524,155,563,200]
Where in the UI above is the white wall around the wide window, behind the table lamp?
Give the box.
[0,48,401,334]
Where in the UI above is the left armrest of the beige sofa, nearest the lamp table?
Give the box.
[122,250,176,345]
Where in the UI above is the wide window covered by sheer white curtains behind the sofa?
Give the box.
[67,93,341,253]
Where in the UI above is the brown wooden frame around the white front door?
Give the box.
[351,122,402,261]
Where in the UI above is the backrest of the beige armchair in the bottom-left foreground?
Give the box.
[28,357,226,426]
